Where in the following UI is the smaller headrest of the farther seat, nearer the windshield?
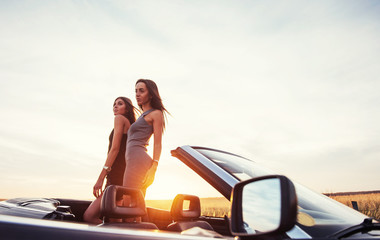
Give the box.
[170,194,201,221]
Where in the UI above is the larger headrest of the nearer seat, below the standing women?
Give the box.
[100,185,145,218]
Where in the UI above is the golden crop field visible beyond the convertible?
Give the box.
[146,191,380,220]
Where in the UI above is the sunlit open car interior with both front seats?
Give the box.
[57,185,231,236]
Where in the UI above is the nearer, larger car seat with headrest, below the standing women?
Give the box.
[99,185,158,229]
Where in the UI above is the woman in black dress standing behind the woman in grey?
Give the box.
[83,97,137,224]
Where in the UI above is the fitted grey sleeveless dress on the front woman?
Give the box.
[123,109,156,195]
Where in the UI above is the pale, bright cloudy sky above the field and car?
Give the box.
[0,0,380,199]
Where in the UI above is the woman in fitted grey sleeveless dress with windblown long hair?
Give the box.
[123,79,167,197]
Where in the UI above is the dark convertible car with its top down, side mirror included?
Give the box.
[0,146,380,240]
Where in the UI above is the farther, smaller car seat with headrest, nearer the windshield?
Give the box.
[167,194,214,232]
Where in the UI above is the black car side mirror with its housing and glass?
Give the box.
[230,175,297,239]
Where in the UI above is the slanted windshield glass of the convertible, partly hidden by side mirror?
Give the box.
[196,148,366,235]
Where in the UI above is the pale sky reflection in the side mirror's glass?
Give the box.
[242,178,281,233]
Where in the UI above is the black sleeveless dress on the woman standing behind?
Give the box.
[106,129,128,186]
